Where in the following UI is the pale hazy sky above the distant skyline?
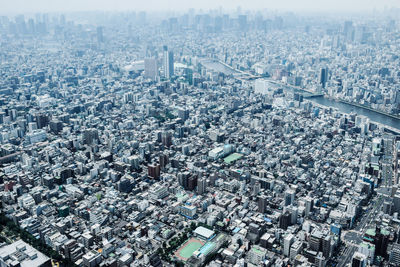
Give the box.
[0,0,400,14]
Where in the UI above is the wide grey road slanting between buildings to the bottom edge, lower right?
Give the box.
[337,195,384,267]
